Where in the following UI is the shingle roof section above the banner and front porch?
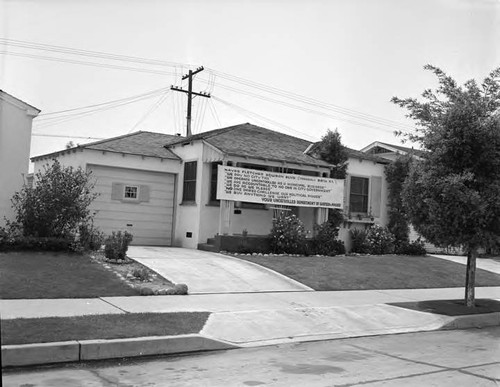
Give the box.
[170,123,329,167]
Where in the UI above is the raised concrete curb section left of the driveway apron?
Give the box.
[2,334,239,368]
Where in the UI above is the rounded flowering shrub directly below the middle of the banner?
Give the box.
[269,214,306,254]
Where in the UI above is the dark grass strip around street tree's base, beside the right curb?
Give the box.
[389,299,500,316]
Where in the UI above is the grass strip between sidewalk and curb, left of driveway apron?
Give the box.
[2,312,210,345]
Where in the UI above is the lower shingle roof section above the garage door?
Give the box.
[32,131,180,160]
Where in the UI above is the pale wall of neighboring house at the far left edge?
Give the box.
[0,90,40,227]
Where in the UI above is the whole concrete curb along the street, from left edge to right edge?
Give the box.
[2,312,500,368]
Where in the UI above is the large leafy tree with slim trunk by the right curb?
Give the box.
[392,65,500,307]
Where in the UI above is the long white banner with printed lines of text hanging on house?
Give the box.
[217,165,344,208]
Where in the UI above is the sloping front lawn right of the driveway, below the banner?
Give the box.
[239,255,500,290]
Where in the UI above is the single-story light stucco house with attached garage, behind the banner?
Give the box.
[32,123,388,252]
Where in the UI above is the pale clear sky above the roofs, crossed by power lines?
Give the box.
[0,0,500,167]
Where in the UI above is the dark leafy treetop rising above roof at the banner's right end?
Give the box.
[317,129,349,179]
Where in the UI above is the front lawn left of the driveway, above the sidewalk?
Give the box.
[0,252,138,299]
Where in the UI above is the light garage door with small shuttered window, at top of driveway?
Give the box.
[88,165,175,246]
